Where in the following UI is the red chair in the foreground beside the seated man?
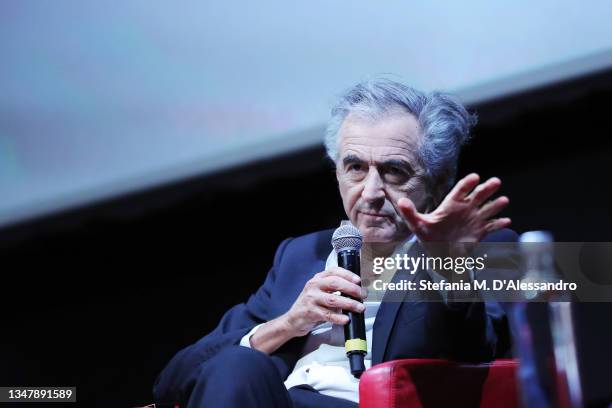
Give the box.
[359,359,518,408]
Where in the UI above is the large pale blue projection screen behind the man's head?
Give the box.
[0,0,612,226]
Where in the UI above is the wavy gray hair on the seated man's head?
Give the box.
[325,79,476,188]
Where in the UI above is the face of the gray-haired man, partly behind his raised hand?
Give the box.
[336,111,431,242]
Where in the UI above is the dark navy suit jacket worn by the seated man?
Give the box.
[154,229,516,402]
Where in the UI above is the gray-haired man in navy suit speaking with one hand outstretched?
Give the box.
[154,80,515,407]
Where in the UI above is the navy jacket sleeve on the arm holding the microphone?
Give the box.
[153,238,291,403]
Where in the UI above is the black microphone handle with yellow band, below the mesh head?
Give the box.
[338,249,368,378]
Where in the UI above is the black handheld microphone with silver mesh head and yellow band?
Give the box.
[332,223,368,378]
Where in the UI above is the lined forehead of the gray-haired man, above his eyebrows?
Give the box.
[339,111,422,162]
